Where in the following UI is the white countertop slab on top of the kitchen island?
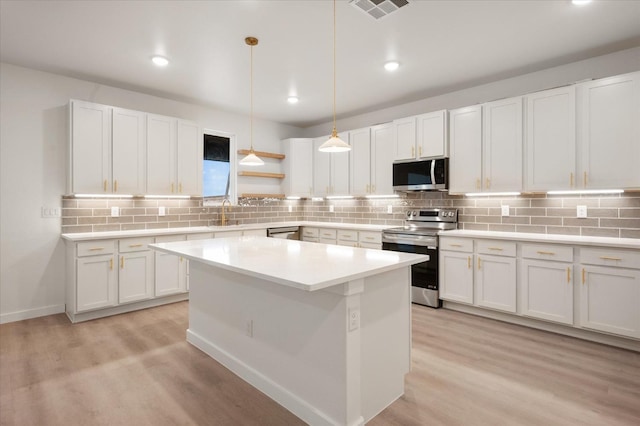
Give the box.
[149,236,429,291]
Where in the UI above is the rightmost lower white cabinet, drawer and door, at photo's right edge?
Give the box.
[579,249,640,338]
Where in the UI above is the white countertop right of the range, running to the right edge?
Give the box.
[439,229,640,249]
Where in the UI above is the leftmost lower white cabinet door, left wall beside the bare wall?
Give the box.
[76,255,117,312]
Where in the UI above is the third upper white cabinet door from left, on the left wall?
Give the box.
[147,114,177,195]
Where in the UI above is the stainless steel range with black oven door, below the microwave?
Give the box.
[382,208,458,308]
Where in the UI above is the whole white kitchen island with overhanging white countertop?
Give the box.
[150,237,428,425]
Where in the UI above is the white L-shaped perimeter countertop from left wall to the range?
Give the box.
[61,221,392,241]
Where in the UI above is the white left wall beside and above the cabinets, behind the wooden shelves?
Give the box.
[0,63,301,323]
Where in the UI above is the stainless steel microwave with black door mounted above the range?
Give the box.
[393,158,449,191]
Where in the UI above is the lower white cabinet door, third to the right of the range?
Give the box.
[520,259,573,325]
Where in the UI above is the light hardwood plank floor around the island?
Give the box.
[0,302,640,426]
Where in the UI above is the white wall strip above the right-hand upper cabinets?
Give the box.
[300,47,640,138]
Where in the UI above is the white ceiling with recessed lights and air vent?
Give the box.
[0,0,640,127]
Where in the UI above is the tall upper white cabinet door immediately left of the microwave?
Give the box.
[371,123,394,195]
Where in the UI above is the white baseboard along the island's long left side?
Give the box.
[187,330,356,426]
